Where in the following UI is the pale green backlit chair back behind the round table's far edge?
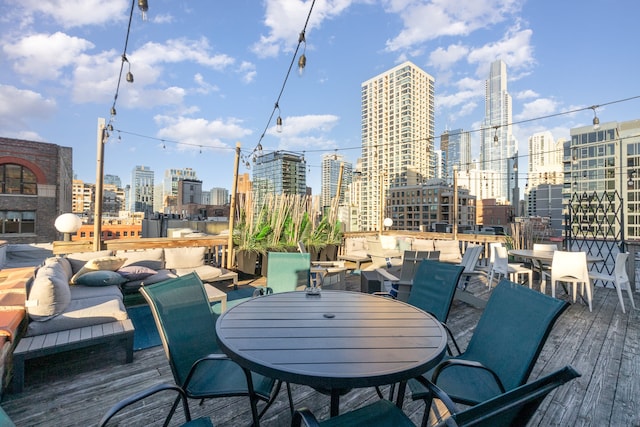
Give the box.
[267,252,311,293]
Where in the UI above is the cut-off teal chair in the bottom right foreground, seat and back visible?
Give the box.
[291,366,580,427]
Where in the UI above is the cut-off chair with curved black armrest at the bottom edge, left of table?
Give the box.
[98,384,213,427]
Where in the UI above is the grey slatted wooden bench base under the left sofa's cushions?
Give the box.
[12,319,135,393]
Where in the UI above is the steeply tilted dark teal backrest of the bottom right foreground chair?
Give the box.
[445,366,580,427]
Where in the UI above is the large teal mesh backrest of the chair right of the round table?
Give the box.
[464,279,569,390]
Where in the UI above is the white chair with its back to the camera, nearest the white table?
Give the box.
[540,251,593,311]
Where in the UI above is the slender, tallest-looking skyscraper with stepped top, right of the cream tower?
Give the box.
[480,60,517,205]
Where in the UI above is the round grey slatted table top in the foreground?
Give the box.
[216,290,447,389]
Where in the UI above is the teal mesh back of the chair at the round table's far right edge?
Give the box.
[407,260,464,322]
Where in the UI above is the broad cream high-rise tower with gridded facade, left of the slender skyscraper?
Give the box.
[360,61,436,231]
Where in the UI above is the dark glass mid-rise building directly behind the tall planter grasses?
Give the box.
[253,151,307,205]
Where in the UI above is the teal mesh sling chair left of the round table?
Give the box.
[140,273,293,425]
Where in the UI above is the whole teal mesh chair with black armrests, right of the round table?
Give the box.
[409,279,569,405]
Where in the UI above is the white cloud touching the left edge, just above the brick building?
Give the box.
[0,84,56,130]
